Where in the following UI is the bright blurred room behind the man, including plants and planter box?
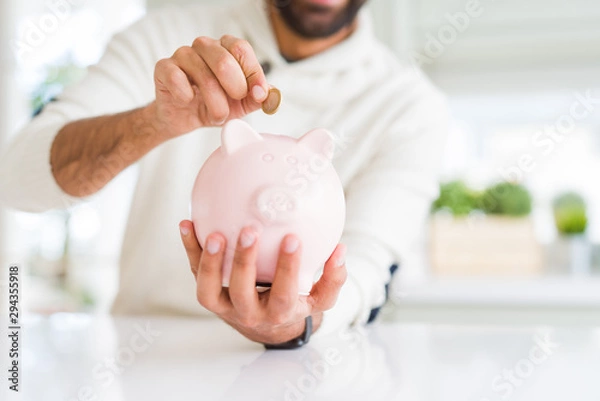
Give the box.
[0,0,600,312]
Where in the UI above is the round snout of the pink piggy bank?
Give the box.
[253,186,298,225]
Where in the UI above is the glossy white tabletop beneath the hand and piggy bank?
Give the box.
[5,314,600,401]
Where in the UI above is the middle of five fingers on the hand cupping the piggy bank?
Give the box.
[229,227,258,320]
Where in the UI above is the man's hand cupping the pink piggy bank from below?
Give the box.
[179,220,347,344]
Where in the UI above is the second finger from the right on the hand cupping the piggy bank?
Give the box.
[268,234,302,323]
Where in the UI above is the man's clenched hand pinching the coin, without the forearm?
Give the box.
[151,35,269,137]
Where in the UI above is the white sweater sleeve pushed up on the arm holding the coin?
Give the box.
[0,12,162,212]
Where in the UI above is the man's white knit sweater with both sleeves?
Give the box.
[0,0,448,332]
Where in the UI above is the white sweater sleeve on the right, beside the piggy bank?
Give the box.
[322,88,448,333]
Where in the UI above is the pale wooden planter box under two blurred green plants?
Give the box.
[430,214,543,277]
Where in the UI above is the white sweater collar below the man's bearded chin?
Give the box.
[236,0,374,73]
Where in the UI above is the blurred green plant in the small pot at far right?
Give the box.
[552,192,588,235]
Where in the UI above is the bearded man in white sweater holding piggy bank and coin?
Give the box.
[0,0,447,344]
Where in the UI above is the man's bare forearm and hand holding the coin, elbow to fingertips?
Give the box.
[50,36,269,196]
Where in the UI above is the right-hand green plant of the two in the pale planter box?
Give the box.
[479,182,531,216]
